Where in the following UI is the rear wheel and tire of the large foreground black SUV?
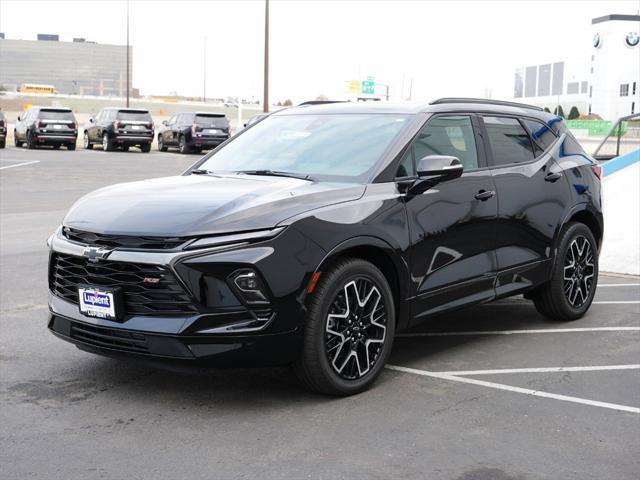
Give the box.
[530,222,598,321]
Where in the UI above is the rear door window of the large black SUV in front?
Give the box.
[483,117,534,165]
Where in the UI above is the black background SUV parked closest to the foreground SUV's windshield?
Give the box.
[158,112,229,153]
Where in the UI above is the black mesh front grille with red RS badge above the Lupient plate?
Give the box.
[49,253,198,315]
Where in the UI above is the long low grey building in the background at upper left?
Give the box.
[0,34,132,97]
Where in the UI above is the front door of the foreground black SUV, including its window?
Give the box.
[403,114,498,323]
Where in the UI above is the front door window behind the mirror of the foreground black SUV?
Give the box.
[414,115,478,170]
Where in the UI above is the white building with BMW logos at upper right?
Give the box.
[514,15,640,120]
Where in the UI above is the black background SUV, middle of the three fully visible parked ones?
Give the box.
[84,107,153,153]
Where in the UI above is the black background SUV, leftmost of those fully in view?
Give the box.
[13,107,78,150]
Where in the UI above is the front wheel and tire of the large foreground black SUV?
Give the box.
[294,258,396,396]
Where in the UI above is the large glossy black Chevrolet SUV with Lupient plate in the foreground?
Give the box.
[49,99,603,395]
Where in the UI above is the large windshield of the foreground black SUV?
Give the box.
[198,114,408,181]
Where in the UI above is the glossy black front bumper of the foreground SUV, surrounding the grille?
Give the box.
[48,230,322,367]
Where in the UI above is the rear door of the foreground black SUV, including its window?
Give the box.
[482,115,571,295]
